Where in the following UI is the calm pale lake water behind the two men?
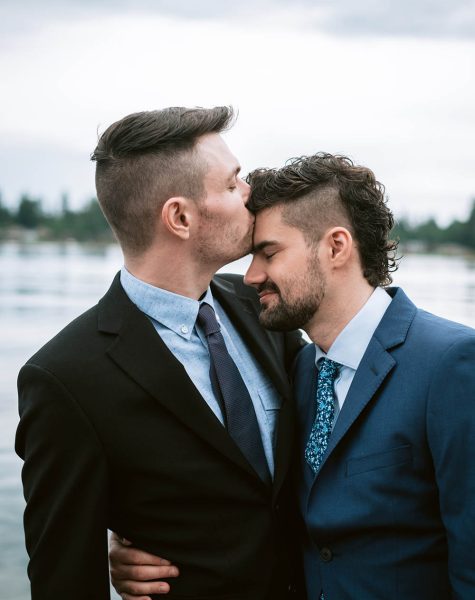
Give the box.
[0,243,475,600]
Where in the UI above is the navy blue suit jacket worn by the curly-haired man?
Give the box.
[295,289,475,600]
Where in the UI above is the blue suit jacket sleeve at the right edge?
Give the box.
[427,335,475,600]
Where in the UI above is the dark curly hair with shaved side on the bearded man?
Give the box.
[247,152,398,287]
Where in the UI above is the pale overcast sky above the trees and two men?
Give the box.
[0,0,475,222]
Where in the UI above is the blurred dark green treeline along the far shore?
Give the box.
[0,195,475,250]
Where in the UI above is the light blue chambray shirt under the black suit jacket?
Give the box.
[120,267,282,475]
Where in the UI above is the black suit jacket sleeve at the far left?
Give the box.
[16,364,110,600]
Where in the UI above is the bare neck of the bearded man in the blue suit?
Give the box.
[304,278,374,352]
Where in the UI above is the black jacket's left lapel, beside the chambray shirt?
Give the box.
[99,277,265,486]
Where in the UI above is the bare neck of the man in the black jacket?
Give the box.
[124,248,220,300]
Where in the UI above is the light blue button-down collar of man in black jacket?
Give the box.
[120,267,215,340]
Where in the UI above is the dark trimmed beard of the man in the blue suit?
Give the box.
[258,257,326,331]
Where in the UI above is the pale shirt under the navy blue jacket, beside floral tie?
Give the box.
[315,287,391,425]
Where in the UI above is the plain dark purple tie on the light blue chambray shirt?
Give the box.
[197,302,271,483]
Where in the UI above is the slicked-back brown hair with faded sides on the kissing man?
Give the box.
[91,106,234,255]
